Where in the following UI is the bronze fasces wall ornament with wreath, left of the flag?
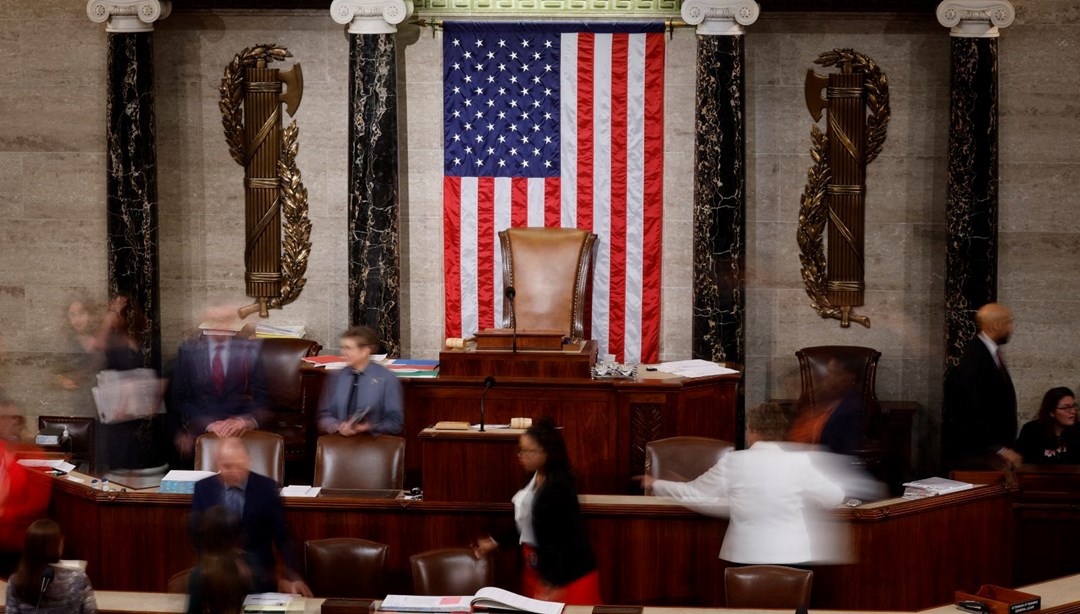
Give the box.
[218,44,311,317]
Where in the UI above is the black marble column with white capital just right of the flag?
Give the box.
[681,0,759,364]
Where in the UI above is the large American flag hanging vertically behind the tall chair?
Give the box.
[443,23,664,363]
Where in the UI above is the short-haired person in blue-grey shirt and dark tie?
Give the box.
[319,326,405,437]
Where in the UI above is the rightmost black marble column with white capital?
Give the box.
[937,0,1015,370]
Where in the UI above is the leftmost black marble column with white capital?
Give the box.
[86,0,172,369]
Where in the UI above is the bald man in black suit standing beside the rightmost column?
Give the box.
[942,303,1022,469]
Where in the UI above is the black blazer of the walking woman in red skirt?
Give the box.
[496,474,596,586]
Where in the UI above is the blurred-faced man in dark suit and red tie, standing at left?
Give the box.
[171,306,269,459]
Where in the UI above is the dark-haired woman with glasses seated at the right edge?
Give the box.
[1016,386,1080,464]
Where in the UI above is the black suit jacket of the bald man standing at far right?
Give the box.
[942,337,1016,466]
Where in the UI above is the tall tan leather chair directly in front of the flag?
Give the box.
[499,228,596,339]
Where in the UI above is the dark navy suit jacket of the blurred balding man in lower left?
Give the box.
[191,473,297,591]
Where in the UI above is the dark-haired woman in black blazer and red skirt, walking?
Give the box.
[474,418,602,605]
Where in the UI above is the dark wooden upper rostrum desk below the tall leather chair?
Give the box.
[300,367,740,494]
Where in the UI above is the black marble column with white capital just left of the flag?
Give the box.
[330,0,413,355]
